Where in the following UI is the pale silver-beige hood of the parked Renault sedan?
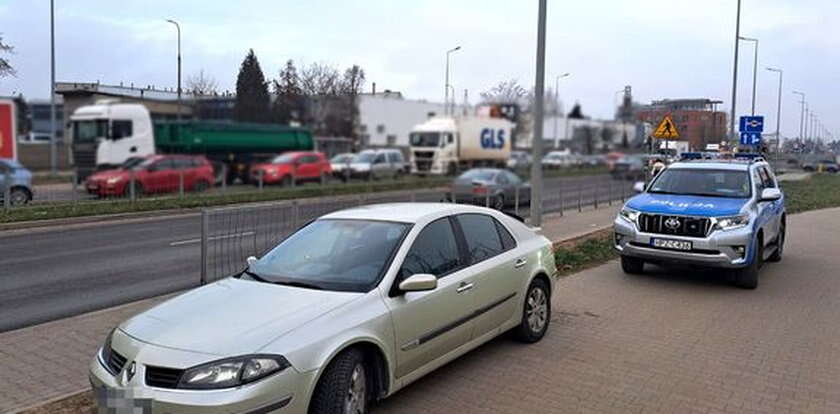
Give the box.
[120,278,362,356]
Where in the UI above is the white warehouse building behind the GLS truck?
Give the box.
[359,90,444,148]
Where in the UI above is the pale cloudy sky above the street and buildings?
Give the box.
[0,0,840,137]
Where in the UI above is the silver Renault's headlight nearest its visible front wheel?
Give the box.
[178,355,291,390]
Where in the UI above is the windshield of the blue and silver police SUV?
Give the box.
[648,168,751,198]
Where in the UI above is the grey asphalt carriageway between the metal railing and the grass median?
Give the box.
[0,175,630,332]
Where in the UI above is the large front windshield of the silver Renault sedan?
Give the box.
[249,219,410,292]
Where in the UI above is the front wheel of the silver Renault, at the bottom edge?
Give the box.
[309,349,372,414]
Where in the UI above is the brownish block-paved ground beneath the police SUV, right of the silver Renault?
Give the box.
[376,208,840,414]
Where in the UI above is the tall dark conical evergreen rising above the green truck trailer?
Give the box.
[233,49,271,122]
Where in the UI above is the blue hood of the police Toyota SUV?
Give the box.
[627,193,748,217]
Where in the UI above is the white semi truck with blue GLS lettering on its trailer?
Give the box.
[409,116,514,175]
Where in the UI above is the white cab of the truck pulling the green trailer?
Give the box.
[70,100,155,180]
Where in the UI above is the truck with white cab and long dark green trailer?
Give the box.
[70,101,315,182]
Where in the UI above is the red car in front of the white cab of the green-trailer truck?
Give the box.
[85,155,215,197]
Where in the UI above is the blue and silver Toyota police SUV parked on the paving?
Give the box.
[614,156,786,289]
